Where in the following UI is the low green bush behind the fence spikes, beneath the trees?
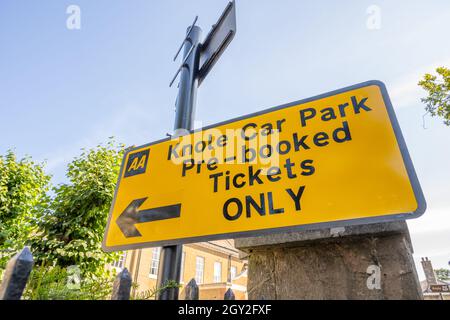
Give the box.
[23,266,114,300]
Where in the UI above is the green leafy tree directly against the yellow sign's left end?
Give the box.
[32,140,123,278]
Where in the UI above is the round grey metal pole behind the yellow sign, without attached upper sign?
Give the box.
[158,26,202,300]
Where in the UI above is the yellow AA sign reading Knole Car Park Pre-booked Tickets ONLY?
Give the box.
[103,81,426,251]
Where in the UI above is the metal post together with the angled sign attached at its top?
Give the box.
[158,1,236,300]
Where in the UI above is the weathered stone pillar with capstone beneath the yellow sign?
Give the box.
[235,222,423,300]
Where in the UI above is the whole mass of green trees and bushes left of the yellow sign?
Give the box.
[0,140,133,300]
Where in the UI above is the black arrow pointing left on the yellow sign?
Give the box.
[116,198,181,238]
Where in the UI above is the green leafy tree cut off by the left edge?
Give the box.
[0,150,50,268]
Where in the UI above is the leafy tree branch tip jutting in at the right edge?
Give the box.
[419,67,450,126]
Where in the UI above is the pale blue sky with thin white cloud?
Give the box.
[0,0,450,279]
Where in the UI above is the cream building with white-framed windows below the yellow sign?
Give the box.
[111,240,247,300]
